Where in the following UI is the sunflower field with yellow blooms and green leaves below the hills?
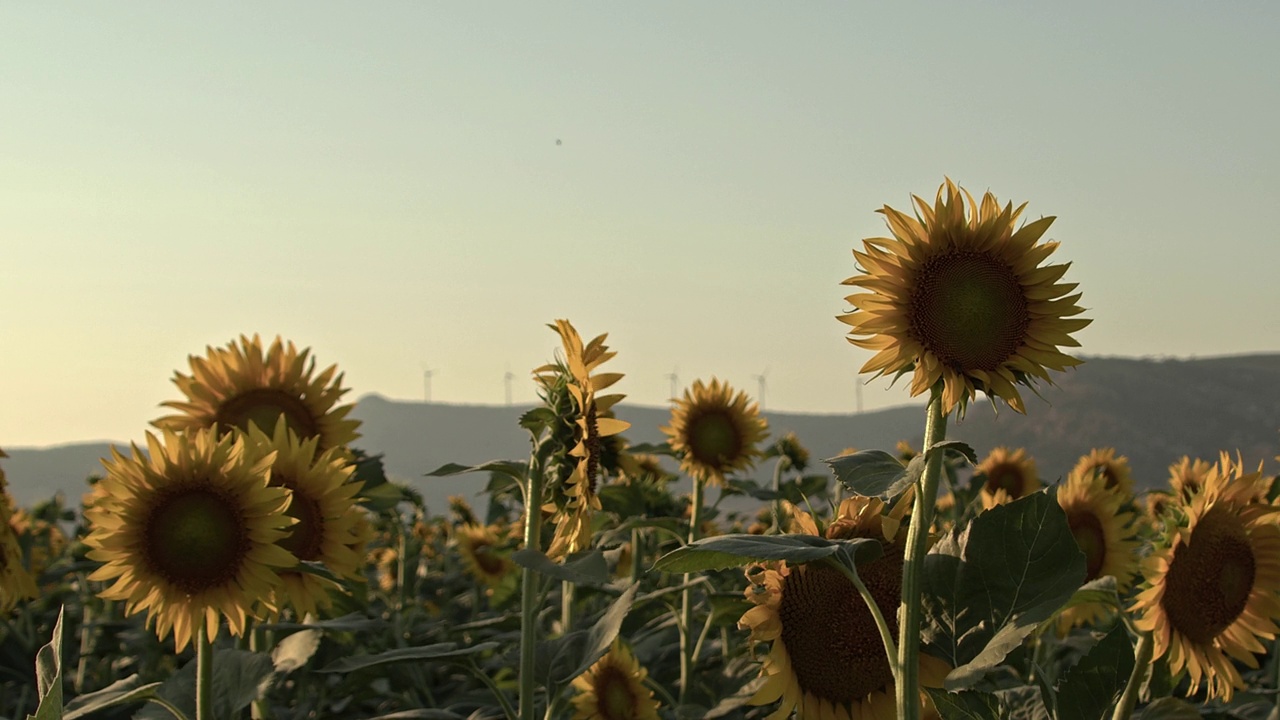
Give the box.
[0,181,1280,720]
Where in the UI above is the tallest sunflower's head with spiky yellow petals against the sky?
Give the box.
[840,179,1091,415]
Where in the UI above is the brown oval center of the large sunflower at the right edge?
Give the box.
[1160,507,1257,643]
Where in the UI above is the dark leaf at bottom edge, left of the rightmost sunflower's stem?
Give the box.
[1046,623,1133,720]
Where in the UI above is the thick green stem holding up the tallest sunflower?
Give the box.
[897,382,947,720]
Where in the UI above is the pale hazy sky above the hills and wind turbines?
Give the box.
[0,1,1280,447]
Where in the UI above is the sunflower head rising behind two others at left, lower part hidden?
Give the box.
[159,334,360,452]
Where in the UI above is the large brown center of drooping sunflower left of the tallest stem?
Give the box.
[778,548,902,706]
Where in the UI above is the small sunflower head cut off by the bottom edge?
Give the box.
[572,639,659,720]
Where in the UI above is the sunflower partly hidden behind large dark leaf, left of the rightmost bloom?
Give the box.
[1057,471,1140,634]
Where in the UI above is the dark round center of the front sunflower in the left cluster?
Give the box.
[142,487,248,594]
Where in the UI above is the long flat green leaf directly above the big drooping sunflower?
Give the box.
[653,534,882,573]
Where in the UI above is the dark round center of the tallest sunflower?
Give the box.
[909,250,1030,372]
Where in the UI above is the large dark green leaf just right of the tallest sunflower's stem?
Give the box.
[922,492,1085,691]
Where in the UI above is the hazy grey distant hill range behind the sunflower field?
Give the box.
[4,354,1280,507]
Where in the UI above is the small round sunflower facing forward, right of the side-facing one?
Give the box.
[662,378,768,486]
